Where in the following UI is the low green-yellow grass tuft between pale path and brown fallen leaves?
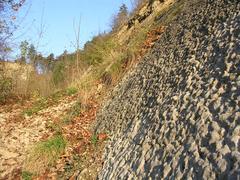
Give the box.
[24,135,67,174]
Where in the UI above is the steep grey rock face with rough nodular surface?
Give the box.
[95,0,240,179]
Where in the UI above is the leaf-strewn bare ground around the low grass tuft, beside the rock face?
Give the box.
[0,95,106,179]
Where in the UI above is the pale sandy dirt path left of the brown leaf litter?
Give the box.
[0,97,75,179]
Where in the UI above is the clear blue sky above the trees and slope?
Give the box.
[15,0,133,55]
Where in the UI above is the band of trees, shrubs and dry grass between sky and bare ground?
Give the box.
[0,0,157,103]
